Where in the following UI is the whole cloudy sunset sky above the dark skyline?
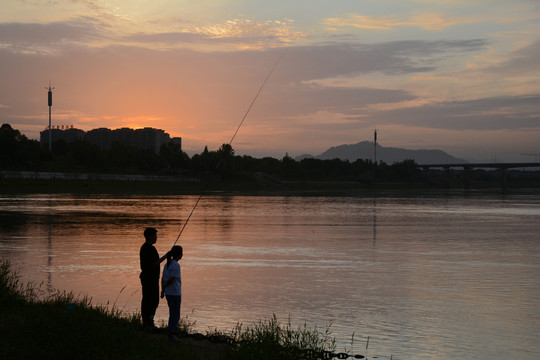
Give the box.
[0,0,540,162]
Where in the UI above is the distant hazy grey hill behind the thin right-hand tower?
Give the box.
[295,141,468,164]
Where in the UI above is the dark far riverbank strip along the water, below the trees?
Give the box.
[0,172,540,196]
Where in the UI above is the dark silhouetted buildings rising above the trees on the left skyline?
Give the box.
[40,127,182,154]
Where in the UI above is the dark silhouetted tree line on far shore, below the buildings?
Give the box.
[0,124,420,181]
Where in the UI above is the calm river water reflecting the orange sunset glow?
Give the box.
[0,195,540,359]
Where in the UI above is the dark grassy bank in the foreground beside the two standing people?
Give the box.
[0,261,335,360]
